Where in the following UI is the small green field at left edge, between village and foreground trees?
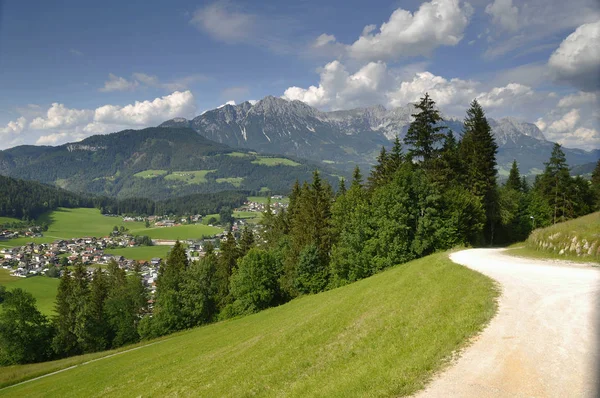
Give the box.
[0,268,59,316]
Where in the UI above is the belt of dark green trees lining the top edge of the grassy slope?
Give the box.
[0,95,600,364]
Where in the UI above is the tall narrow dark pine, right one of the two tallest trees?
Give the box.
[459,100,499,244]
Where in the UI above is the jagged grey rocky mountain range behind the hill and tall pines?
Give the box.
[161,96,600,175]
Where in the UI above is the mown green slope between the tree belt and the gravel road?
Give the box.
[0,253,498,397]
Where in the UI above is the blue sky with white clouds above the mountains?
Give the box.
[0,0,600,150]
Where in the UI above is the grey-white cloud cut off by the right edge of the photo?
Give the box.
[548,20,600,91]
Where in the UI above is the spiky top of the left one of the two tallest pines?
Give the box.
[404,93,445,166]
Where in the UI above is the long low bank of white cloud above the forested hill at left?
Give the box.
[0,91,196,147]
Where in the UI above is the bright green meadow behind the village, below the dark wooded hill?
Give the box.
[0,208,145,247]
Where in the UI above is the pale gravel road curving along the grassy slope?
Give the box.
[417,249,600,397]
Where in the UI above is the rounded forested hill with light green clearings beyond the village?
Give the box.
[0,127,338,200]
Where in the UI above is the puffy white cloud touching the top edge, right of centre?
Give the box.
[348,0,473,60]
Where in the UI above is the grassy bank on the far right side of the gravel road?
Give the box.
[508,212,600,263]
